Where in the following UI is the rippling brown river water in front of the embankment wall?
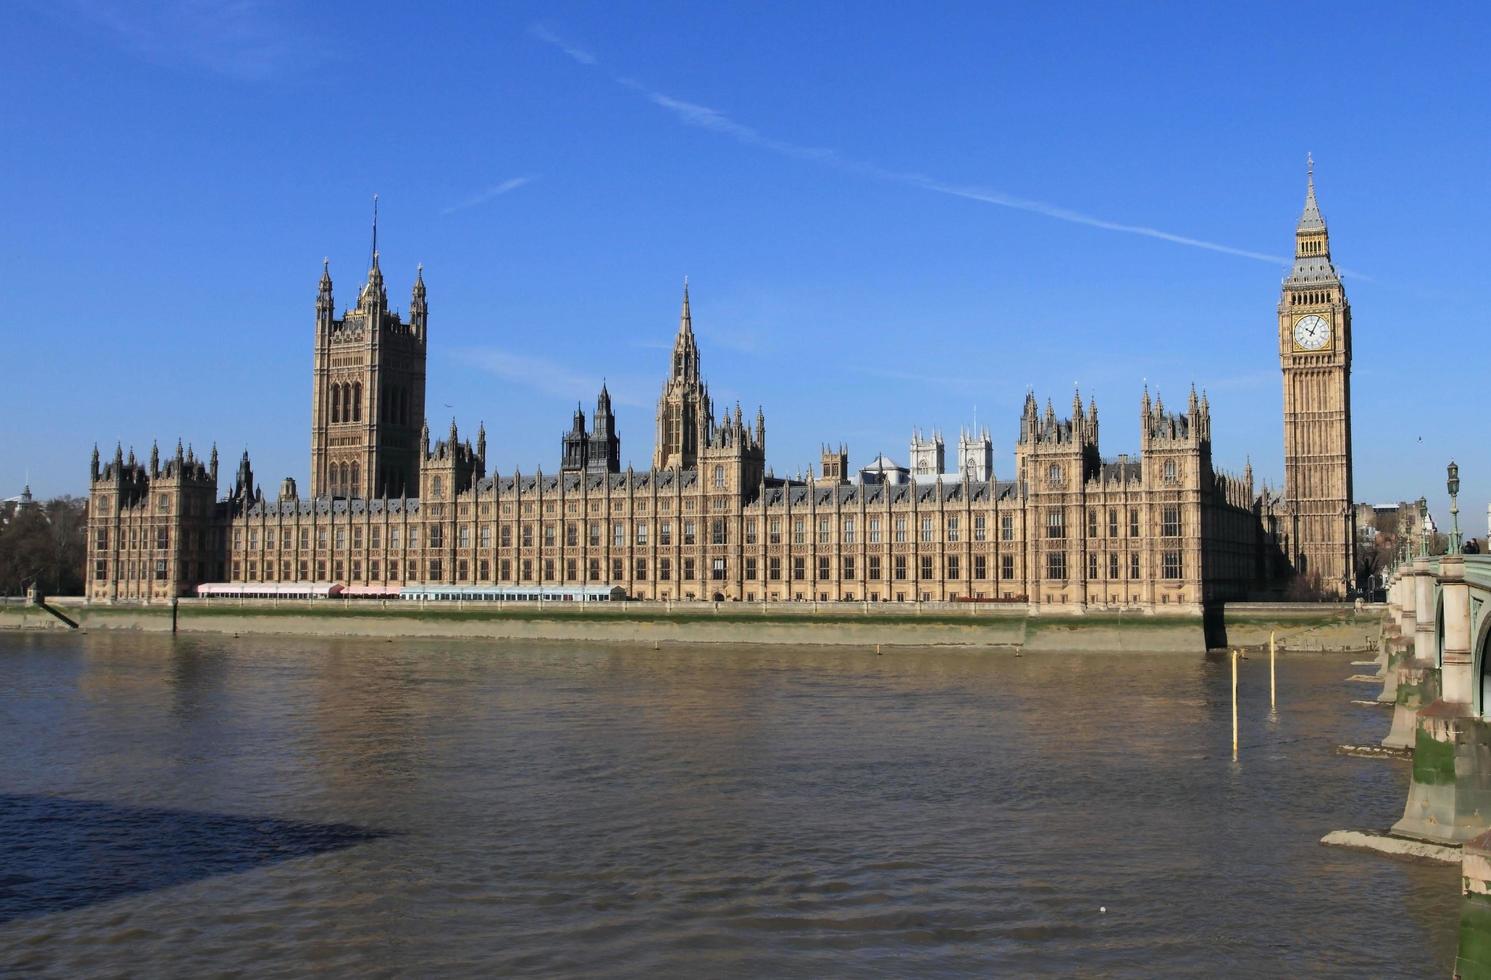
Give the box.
[0,634,1458,977]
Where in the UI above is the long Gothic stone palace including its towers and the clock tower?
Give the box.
[88,176,1355,612]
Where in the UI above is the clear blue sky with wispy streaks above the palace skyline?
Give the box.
[0,0,1491,534]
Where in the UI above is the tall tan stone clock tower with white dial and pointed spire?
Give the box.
[1279,160,1357,595]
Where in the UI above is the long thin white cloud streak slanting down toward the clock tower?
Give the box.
[529,24,1318,271]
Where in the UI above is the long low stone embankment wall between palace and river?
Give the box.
[0,600,1379,652]
